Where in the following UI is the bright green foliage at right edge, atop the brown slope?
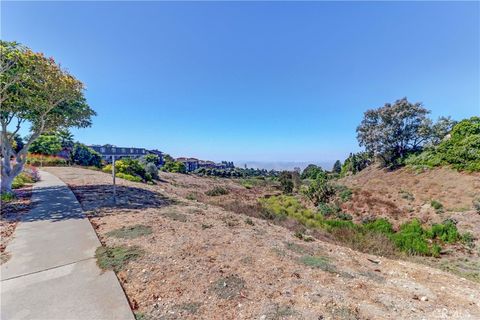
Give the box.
[406,117,480,171]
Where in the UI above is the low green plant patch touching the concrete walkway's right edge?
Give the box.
[95,246,143,272]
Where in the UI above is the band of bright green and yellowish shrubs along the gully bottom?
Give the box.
[259,195,471,256]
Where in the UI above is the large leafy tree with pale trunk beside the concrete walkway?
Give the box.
[0,41,95,192]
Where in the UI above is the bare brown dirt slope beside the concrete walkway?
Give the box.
[43,168,480,319]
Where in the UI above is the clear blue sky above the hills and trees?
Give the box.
[1,1,480,161]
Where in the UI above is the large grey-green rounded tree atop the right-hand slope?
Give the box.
[357,98,431,166]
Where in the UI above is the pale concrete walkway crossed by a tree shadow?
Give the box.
[0,172,134,320]
